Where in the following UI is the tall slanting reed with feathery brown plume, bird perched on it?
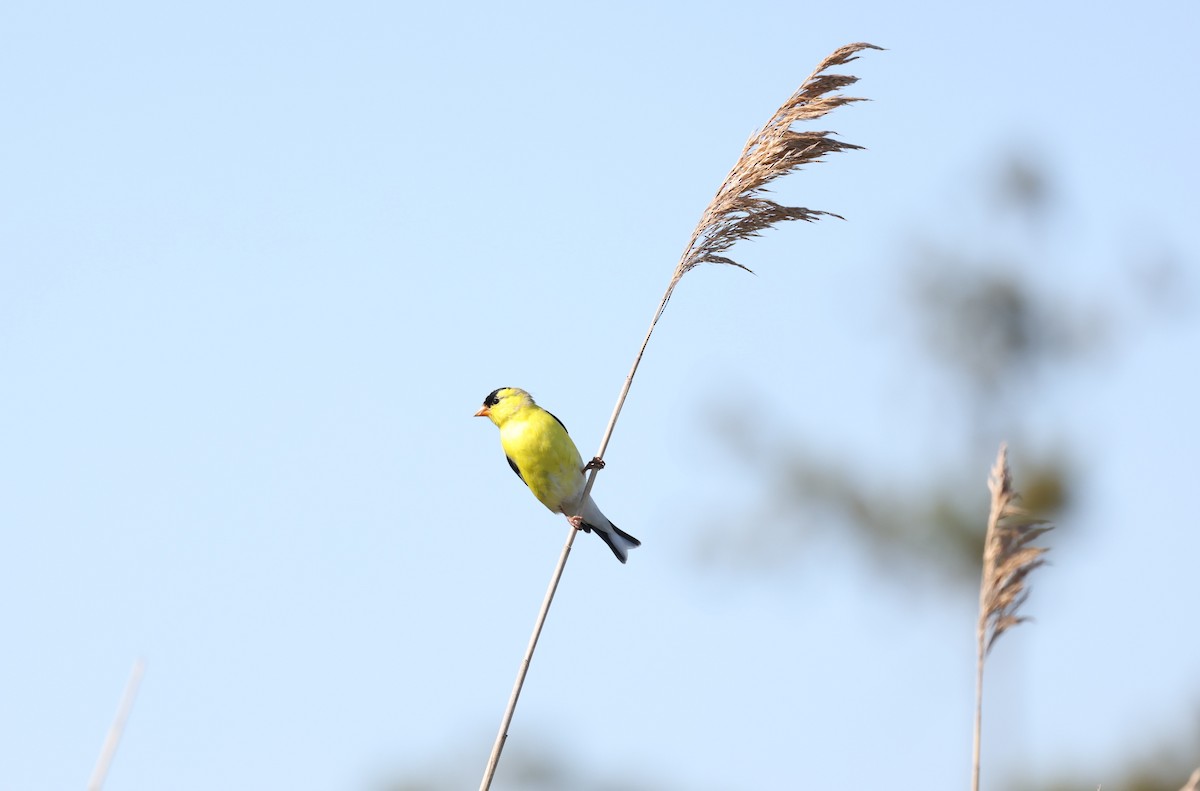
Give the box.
[479,43,880,791]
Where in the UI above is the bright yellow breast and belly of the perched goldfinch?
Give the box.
[500,407,584,513]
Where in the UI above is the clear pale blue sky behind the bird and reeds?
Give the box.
[0,2,1200,791]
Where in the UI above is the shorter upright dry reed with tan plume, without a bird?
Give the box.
[971,444,1051,791]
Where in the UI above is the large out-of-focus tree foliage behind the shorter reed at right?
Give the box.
[700,148,1177,585]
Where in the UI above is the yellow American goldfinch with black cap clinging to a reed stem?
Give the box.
[475,388,642,563]
